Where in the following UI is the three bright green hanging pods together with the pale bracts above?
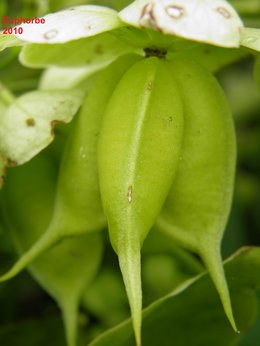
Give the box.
[0,0,260,345]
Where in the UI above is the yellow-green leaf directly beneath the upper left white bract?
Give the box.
[20,33,139,68]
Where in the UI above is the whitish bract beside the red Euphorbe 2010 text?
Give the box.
[17,5,122,44]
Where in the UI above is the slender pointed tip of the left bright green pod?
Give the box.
[0,229,59,282]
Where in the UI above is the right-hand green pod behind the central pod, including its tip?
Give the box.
[157,58,237,330]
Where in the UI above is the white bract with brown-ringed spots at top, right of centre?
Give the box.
[119,0,243,47]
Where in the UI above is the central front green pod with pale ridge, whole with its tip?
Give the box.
[98,57,183,345]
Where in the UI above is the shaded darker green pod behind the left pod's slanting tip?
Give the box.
[4,154,103,346]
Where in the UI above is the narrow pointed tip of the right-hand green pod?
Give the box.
[200,249,240,333]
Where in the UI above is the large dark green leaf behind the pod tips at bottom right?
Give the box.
[89,248,260,346]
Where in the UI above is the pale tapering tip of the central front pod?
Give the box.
[118,246,142,346]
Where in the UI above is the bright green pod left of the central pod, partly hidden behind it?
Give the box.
[0,54,141,281]
